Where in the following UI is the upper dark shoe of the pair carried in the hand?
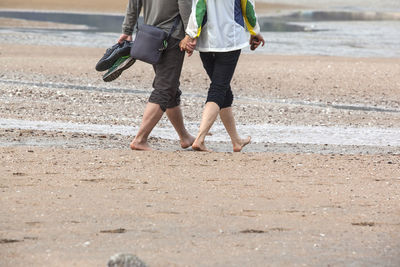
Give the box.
[96,41,132,71]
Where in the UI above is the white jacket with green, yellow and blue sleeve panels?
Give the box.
[186,0,260,52]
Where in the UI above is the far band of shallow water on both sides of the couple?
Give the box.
[0,11,400,58]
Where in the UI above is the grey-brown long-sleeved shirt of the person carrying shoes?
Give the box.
[122,0,192,39]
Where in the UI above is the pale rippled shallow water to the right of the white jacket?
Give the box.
[257,21,400,58]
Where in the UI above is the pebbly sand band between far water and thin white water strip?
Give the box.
[0,45,400,131]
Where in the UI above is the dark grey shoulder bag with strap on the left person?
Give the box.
[131,0,180,65]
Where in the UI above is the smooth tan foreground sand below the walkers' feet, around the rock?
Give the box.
[0,147,400,266]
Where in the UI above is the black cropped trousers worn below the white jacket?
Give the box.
[200,50,241,109]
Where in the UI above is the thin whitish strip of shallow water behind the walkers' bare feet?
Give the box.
[0,119,400,148]
